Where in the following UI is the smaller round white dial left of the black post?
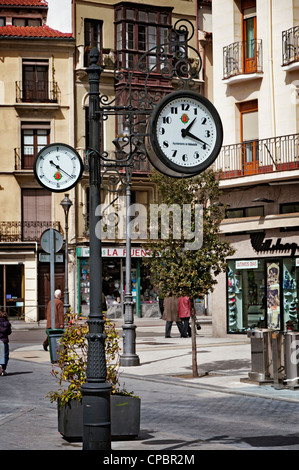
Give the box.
[33,144,83,192]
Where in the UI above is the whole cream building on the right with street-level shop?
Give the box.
[210,0,299,337]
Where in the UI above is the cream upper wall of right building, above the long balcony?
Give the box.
[213,0,299,145]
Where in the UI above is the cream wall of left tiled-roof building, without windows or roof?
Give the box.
[0,40,76,322]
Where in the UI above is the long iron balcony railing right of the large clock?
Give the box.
[214,134,299,178]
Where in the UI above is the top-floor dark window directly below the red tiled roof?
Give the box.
[22,60,49,102]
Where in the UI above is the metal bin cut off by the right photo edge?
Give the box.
[284,331,299,388]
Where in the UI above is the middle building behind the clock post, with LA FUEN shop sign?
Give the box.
[74,0,202,316]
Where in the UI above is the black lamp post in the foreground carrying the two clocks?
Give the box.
[82,47,112,450]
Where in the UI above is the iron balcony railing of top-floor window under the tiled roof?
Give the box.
[16,80,60,103]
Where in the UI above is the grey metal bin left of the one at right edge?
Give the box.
[247,330,272,382]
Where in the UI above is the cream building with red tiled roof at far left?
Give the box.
[0,0,75,321]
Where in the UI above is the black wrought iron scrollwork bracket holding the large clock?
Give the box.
[89,19,202,202]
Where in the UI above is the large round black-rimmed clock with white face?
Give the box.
[148,91,223,176]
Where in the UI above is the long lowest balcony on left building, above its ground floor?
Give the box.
[0,221,60,242]
